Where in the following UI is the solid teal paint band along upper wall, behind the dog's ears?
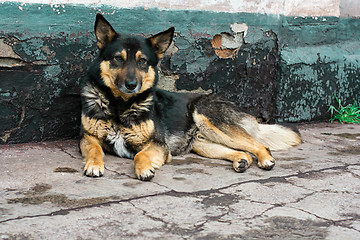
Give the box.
[0,2,281,39]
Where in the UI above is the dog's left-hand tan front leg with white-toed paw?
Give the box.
[80,134,104,177]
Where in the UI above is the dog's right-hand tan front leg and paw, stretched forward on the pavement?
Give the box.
[134,142,171,181]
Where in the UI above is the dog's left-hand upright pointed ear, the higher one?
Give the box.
[95,13,117,49]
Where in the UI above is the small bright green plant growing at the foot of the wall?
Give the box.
[328,93,360,123]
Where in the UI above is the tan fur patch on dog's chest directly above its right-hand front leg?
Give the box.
[121,120,154,151]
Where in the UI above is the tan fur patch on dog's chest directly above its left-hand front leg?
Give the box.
[81,114,113,140]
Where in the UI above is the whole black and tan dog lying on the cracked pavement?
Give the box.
[80,14,301,180]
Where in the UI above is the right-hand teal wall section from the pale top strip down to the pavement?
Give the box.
[276,17,360,121]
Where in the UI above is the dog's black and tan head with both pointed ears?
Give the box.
[95,14,174,101]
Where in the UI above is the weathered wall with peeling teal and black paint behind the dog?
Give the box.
[0,0,360,143]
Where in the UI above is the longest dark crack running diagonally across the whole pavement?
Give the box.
[0,163,360,223]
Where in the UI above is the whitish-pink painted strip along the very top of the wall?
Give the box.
[0,0,344,17]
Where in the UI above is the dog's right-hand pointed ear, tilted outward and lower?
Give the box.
[149,27,175,59]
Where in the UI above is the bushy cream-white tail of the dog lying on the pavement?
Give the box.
[250,124,301,150]
